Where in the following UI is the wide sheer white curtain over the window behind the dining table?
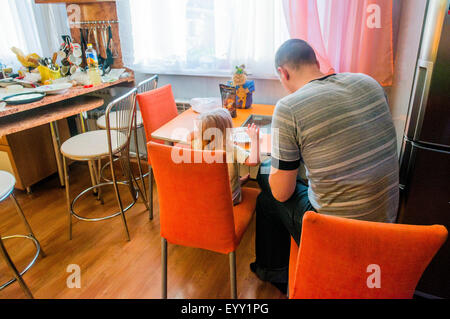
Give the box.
[117,0,289,78]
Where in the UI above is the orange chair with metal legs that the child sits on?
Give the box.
[148,142,259,298]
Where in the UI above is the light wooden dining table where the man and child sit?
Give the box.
[152,104,275,155]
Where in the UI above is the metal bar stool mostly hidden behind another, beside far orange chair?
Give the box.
[97,75,158,220]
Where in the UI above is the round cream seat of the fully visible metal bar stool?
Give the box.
[61,130,127,160]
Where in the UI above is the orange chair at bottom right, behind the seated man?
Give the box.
[289,212,448,299]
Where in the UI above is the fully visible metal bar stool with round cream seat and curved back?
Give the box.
[61,89,148,240]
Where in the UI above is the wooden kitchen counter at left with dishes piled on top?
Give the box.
[0,77,134,186]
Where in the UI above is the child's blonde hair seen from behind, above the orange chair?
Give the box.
[197,108,233,150]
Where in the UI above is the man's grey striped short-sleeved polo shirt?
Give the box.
[272,73,399,222]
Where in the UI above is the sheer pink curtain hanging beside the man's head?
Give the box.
[283,0,394,86]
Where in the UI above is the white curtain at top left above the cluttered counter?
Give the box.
[0,0,70,70]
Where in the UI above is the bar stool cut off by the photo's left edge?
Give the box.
[0,171,45,298]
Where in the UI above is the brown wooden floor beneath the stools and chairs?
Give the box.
[0,163,285,299]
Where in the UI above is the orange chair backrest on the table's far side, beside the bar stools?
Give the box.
[137,84,178,143]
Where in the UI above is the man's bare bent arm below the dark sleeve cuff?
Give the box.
[269,166,298,203]
